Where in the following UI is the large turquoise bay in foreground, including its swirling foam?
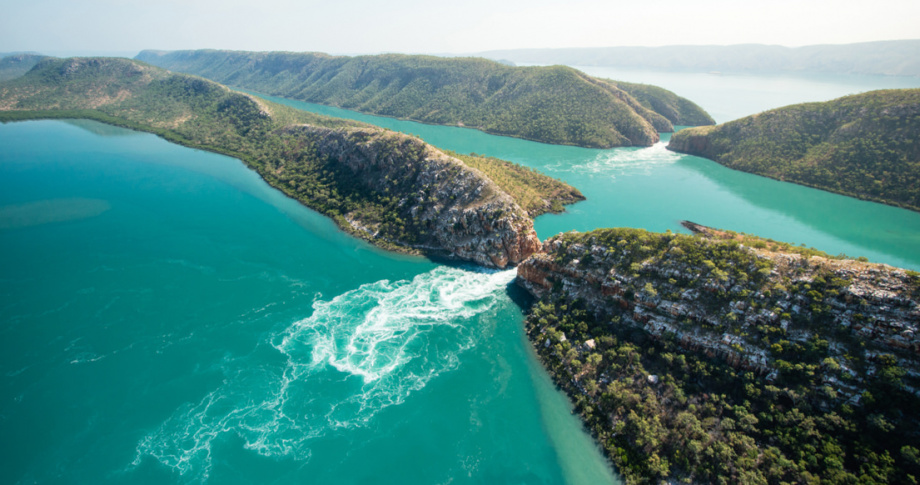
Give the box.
[0,121,615,484]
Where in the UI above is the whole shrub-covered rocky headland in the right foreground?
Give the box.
[518,229,920,484]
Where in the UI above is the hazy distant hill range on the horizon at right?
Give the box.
[478,40,920,76]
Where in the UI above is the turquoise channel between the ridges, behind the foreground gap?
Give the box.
[255,92,920,269]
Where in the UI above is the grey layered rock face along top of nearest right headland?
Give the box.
[517,230,920,396]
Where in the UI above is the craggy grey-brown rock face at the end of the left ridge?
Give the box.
[288,125,541,268]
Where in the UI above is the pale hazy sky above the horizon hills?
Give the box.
[0,0,920,55]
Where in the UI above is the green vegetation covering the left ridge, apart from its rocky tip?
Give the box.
[0,58,574,258]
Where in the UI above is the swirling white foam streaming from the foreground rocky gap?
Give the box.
[133,267,515,481]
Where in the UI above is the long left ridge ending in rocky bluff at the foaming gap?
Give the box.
[0,58,584,267]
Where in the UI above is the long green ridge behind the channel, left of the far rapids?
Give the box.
[137,50,714,148]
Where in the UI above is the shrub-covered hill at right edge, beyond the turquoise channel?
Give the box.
[668,89,920,210]
